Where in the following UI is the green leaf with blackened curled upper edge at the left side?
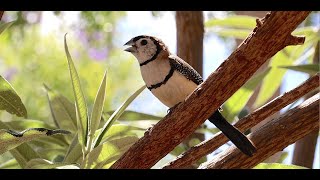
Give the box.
[0,128,70,155]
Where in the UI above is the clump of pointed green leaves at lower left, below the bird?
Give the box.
[0,24,148,169]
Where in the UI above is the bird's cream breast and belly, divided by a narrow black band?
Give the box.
[141,61,197,108]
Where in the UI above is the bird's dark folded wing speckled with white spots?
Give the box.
[169,55,203,85]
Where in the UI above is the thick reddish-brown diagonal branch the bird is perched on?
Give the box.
[111,11,310,168]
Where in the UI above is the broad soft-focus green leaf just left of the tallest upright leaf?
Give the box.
[44,84,77,132]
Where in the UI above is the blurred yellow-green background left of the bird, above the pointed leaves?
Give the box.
[0,11,143,120]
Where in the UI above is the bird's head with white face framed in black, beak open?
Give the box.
[124,35,169,63]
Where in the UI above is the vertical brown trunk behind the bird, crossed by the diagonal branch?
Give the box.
[175,11,205,168]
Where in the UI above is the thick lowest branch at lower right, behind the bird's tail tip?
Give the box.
[200,93,320,169]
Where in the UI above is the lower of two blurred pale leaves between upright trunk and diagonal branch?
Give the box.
[209,28,252,39]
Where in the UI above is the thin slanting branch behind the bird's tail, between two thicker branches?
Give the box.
[164,73,320,168]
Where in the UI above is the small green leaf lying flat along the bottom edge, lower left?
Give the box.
[25,158,78,169]
